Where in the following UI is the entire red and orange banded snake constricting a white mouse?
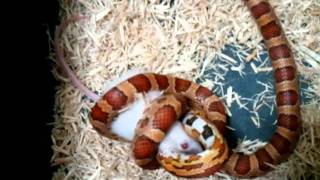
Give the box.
[91,0,301,177]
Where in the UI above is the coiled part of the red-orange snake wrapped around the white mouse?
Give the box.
[91,73,228,177]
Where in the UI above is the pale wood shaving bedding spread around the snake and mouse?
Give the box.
[52,0,320,180]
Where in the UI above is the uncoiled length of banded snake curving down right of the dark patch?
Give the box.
[224,0,301,177]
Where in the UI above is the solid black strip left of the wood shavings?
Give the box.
[9,0,59,179]
